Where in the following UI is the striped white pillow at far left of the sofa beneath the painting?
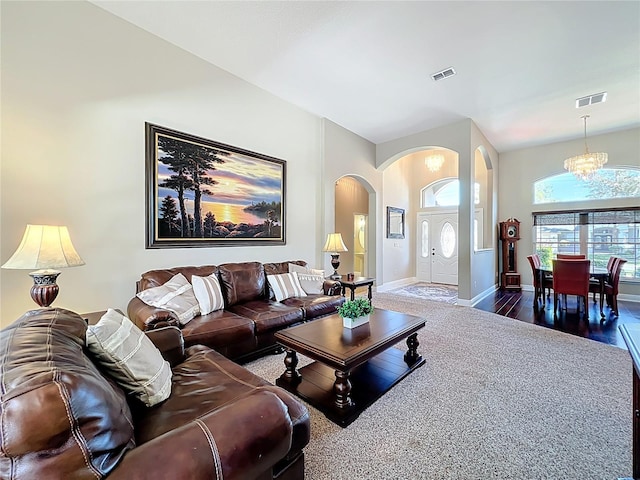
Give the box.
[136,273,200,325]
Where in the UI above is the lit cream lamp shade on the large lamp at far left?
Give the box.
[2,225,84,270]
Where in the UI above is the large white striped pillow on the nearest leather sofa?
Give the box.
[87,308,171,407]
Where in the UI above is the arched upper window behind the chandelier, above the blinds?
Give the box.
[533,167,640,203]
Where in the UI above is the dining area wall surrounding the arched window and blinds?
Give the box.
[498,128,640,295]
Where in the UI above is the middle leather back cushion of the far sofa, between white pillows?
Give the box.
[218,262,267,308]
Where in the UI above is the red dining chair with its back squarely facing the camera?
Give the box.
[553,259,591,320]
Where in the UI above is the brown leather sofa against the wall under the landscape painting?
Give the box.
[127,260,344,361]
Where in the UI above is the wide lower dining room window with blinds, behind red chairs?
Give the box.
[533,207,640,281]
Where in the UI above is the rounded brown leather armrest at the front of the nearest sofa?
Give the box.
[108,390,292,480]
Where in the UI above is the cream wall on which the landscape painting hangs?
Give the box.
[0,2,324,326]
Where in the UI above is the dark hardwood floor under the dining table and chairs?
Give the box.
[475,290,640,349]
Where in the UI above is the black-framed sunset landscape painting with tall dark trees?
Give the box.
[145,123,286,248]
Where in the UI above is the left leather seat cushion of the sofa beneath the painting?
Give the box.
[182,310,255,349]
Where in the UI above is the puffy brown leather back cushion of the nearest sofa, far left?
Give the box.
[0,308,135,480]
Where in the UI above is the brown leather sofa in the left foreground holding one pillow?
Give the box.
[0,308,310,480]
